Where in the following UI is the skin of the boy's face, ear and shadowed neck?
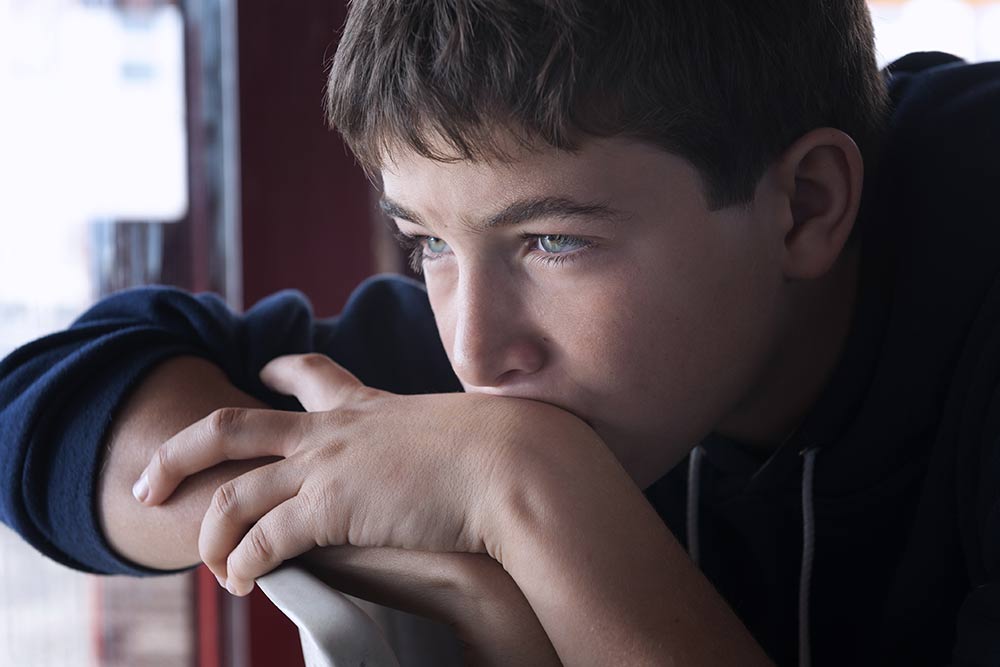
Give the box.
[382,130,861,480]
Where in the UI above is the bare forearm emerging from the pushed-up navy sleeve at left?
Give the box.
[97,357,274,569]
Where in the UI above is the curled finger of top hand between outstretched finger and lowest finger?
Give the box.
[198,461,302,579]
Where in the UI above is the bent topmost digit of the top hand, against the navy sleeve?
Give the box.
[260,353,364,412]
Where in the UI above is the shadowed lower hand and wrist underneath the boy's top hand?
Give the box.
[297,546,560,667]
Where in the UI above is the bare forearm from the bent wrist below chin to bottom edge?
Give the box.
[492,434,771,665]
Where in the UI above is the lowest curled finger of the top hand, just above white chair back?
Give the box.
[226,494,317,595]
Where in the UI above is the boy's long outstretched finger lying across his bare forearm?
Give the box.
[132,408,305,505]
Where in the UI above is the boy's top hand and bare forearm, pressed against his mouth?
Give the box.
[137,355,771,665]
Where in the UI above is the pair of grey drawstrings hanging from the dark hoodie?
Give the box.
[687,445,819,667]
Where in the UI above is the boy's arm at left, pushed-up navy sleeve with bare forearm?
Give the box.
[0,278,457,575]
